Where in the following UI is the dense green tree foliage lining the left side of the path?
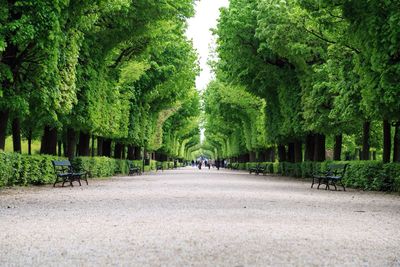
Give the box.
[0,0,199,161]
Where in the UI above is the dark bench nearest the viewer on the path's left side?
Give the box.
[51,160,89,187]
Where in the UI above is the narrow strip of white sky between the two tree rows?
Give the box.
[186,0,229,90]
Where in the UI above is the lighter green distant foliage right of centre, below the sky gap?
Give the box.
[204,81,266,157]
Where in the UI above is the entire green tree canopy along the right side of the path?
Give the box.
[204,0,400,162]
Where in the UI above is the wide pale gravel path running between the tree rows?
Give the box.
[0,168,400,266]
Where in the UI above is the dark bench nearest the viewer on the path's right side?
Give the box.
[311,164,348,191]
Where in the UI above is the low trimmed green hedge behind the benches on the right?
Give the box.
[230,161,400,192]
